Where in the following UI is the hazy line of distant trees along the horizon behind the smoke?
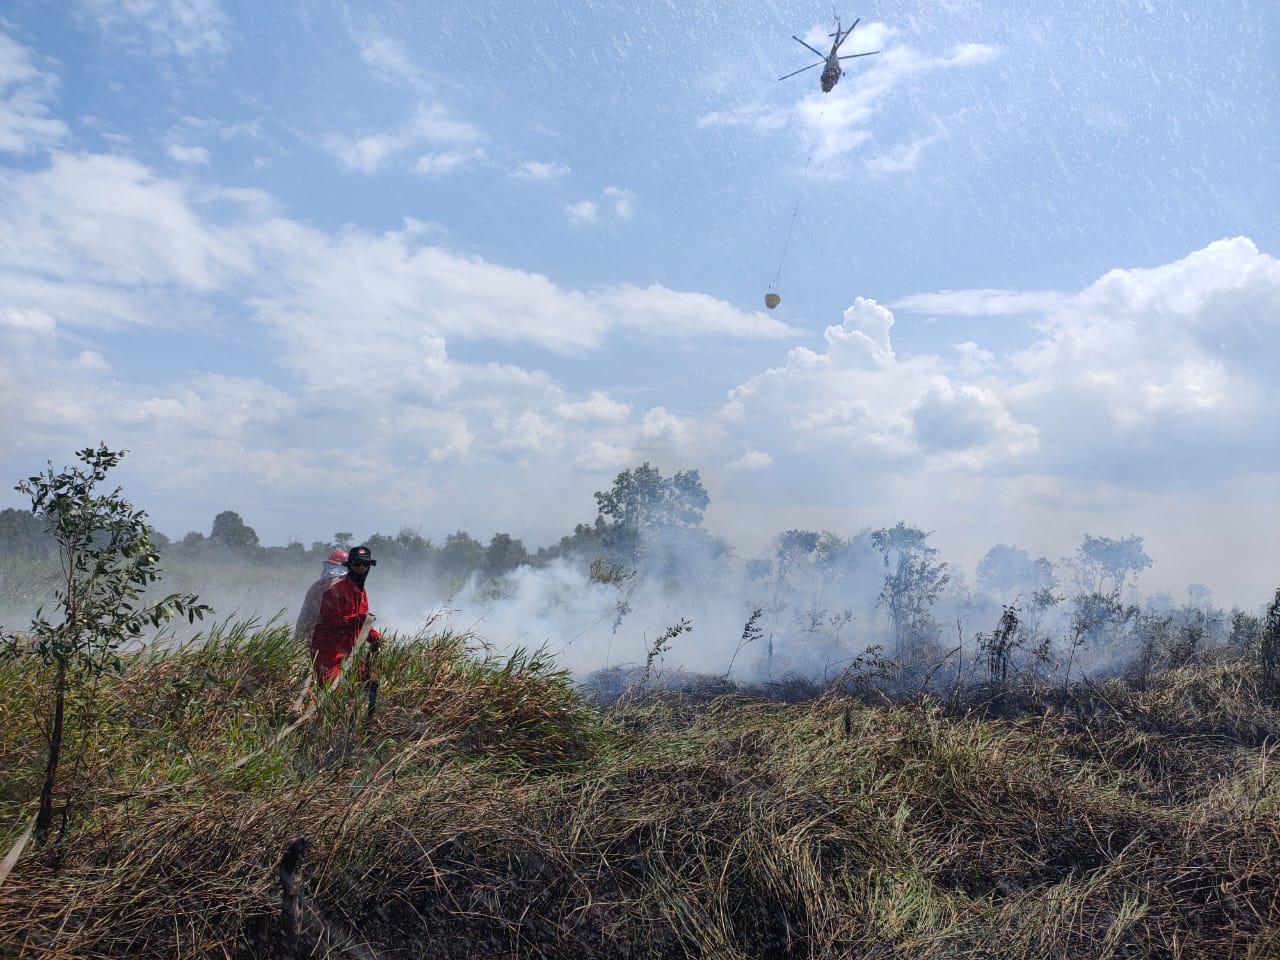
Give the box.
[0,461,1257,675]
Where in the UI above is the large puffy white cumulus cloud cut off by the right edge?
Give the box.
[1011,238,1280,483]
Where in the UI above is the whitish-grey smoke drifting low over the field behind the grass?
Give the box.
[0,524,1261,686]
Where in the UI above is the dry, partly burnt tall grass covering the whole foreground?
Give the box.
[0,625,1280,960]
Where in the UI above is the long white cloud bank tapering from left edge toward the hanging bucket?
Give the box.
[0,146,788,371]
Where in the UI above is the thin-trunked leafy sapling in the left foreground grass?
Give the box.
[4,444,210,842]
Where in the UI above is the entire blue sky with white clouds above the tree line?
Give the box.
[0,0,1280,605]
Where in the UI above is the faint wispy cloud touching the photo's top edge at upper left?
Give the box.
[79,0,230,58]
